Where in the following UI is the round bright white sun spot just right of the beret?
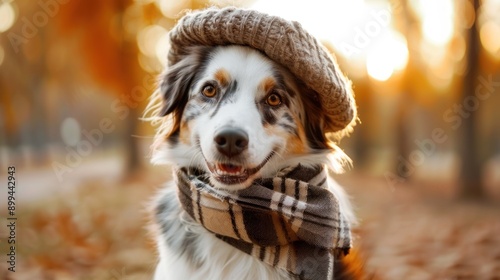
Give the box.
[366,31,408,81]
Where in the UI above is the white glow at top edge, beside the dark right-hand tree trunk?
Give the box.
[412,0,455,45]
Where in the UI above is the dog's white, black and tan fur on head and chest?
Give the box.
[148,46,362,280]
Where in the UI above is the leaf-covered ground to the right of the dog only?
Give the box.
[344,178,500,280]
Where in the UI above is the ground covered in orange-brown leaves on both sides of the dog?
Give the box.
[0,167,500,280]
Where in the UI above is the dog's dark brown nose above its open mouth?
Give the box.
[214,127,248,157]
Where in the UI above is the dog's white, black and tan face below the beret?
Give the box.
[150,46,330,190]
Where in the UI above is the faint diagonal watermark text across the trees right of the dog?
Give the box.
[384,75,500,187]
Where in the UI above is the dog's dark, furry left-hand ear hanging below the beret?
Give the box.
[160,47,208,117]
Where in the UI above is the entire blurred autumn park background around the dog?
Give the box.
[0,0,500,279]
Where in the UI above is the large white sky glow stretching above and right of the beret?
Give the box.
[251,0,414,81]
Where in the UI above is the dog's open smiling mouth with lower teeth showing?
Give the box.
[205,152,274,185]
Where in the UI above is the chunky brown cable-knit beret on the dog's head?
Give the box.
[168,7,356,132]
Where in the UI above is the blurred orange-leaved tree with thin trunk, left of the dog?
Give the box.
[57,0,147,171]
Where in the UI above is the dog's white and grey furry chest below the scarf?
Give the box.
[154,186,292,280]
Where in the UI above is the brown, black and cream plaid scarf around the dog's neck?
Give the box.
[175,164,351,280]
